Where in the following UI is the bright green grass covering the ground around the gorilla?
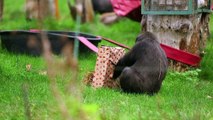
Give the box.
[0,0,213,120]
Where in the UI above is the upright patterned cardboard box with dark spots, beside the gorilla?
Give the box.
[92,46,125,88]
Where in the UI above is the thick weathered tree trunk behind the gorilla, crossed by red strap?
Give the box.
[142,0,210,71]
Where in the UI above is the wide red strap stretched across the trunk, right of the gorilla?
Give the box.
[161,44,201,66]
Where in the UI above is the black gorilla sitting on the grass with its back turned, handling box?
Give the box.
[113,32,168,94]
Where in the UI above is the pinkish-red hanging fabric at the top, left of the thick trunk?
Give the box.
[111,0,142,21]
